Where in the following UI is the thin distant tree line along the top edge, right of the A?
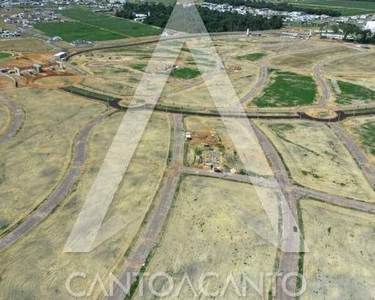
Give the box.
[208,0,342,17]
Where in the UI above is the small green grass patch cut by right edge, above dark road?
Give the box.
[336,80,375,104]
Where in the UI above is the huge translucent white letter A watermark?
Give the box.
[64,3,306,264]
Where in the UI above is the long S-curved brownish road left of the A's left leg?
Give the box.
[0,110,114,251]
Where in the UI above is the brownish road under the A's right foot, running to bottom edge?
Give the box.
[253,125,300,300]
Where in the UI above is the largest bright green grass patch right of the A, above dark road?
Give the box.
[254,69,317,107]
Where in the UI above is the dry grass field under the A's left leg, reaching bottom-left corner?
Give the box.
[0,112,170,300]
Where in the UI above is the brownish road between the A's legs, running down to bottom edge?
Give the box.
[104,114,184,300]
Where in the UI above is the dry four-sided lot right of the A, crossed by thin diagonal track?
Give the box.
[260,121,375,202]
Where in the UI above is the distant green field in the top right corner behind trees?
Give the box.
[288,0,375,16]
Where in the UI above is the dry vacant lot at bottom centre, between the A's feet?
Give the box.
[135,176,277,299]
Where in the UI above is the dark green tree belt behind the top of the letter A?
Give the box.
[116,3,283,33]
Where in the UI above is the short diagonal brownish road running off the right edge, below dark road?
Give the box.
[331,124,375,188]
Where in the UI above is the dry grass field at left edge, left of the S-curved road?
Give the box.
[0,89,105,231]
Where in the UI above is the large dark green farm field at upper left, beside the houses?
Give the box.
[35,8,161,42]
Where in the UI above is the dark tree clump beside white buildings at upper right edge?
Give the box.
[320,22,375,44]
